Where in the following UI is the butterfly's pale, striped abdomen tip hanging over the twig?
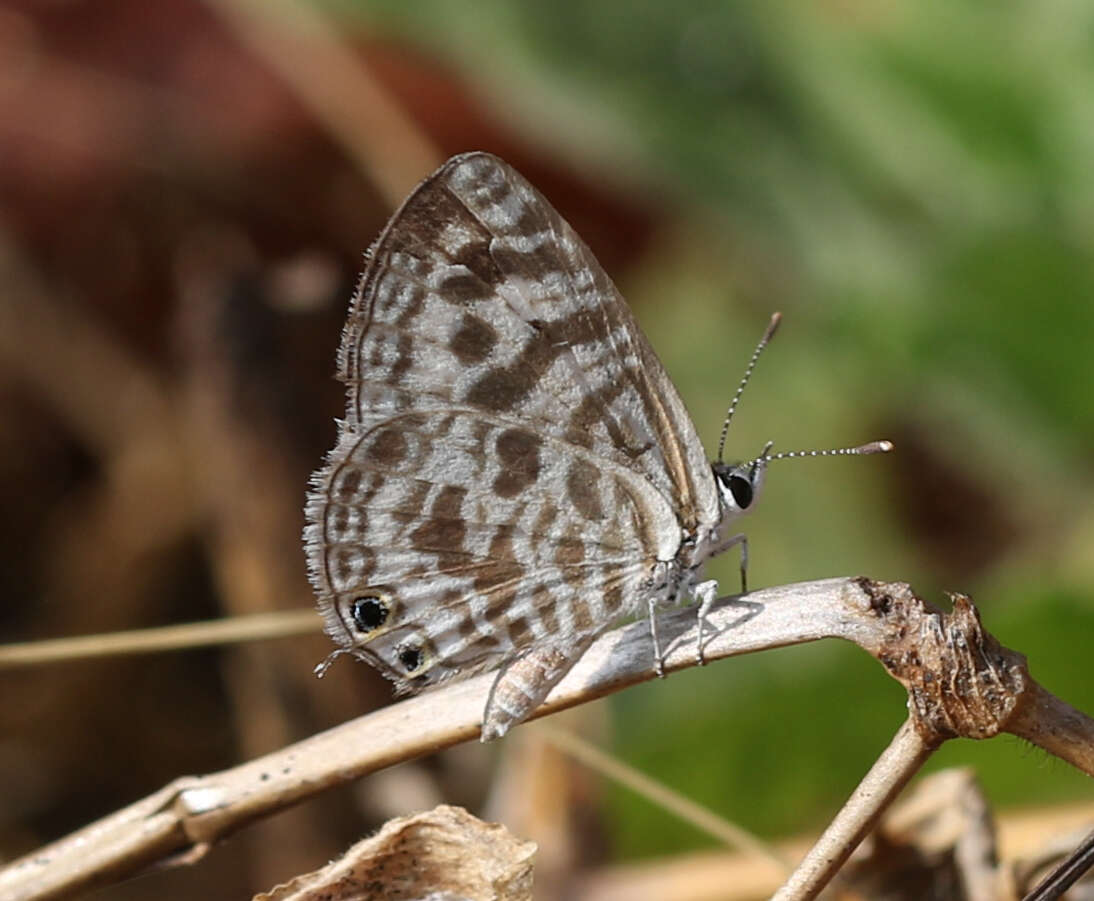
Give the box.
[481,636,593,741]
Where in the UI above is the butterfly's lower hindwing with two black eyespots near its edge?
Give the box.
[310,411,664,690]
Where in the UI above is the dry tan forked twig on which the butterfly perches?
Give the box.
[0,578,1094,901]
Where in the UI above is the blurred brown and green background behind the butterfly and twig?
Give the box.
[0,0,1094,898]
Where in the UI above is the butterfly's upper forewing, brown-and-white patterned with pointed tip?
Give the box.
[339,153,718,528]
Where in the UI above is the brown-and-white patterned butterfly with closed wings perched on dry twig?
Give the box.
[305,153,887,740]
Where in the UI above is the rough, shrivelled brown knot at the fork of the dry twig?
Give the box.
[859,578,1032,744]
